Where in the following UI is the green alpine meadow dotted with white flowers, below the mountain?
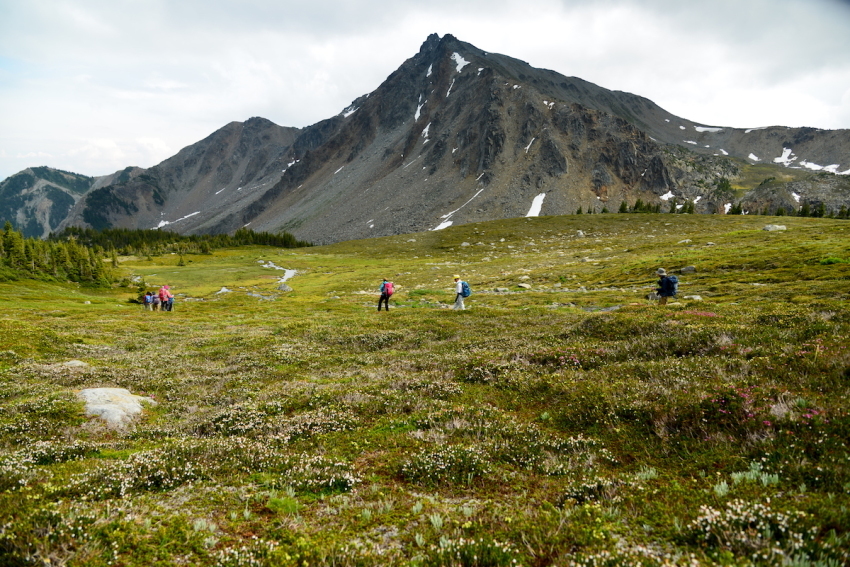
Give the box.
[0,214,850,566]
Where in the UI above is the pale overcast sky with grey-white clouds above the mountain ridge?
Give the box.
[0,0,850,180]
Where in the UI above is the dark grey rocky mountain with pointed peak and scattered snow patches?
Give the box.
[3,34,850,243]
